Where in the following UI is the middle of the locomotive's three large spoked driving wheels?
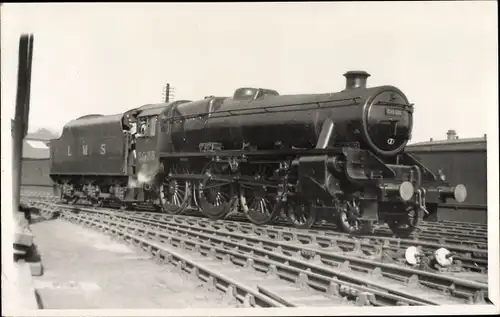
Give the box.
[194,164,238,220]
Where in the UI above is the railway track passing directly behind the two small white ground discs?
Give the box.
[24,202,488,274]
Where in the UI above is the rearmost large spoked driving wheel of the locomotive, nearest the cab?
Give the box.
[160,165,192,214]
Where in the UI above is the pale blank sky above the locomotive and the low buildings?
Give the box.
[1,1,498,142]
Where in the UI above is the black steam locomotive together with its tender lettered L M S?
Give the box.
[50,71,467,236]
